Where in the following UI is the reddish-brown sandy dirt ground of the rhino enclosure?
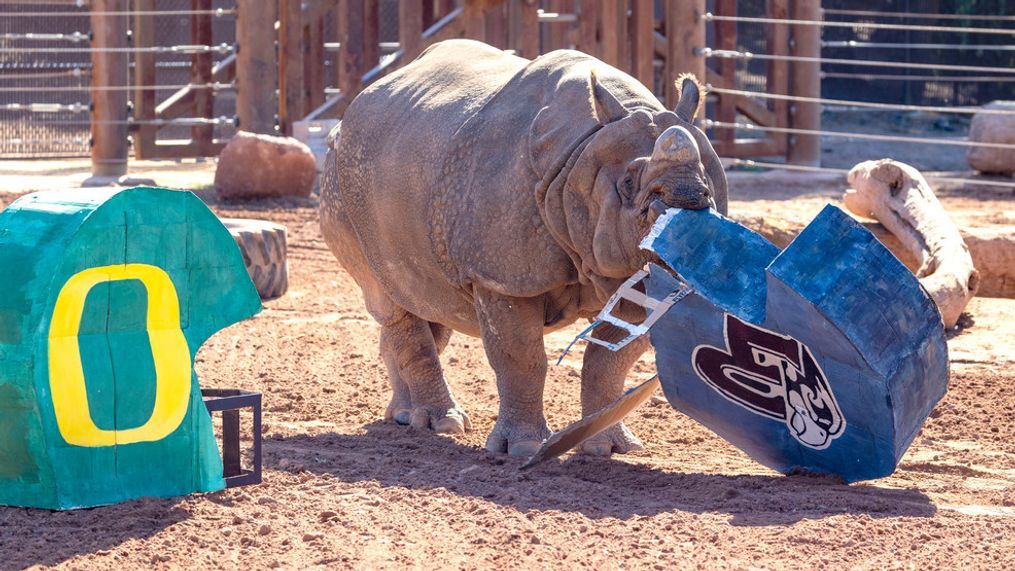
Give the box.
[0,157,1015,569]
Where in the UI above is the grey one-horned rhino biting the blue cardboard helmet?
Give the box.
[321,40,727,455]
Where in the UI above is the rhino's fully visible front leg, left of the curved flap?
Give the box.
[475,288,550,456]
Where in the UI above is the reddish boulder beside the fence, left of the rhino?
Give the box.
[215,132,317,199]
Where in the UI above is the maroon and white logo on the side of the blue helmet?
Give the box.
[691,313,845,449]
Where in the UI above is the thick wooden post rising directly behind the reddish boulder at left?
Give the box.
[236,0,277,135]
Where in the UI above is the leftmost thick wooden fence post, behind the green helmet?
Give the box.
[85,0,129,186]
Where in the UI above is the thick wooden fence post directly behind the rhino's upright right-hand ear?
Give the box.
[663,0,707,109]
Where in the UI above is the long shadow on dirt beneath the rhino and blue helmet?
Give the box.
[265,422,936,525]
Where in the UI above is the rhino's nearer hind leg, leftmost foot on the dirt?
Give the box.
[381,308,472,434]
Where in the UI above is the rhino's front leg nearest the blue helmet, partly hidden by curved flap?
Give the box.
[580,324,649,456]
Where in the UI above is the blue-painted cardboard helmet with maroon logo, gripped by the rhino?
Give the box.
[647,206,948,482]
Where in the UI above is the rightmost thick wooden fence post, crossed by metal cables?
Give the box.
[786,0,821,166]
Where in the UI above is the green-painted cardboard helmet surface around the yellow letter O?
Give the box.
[0,188,261,509]
